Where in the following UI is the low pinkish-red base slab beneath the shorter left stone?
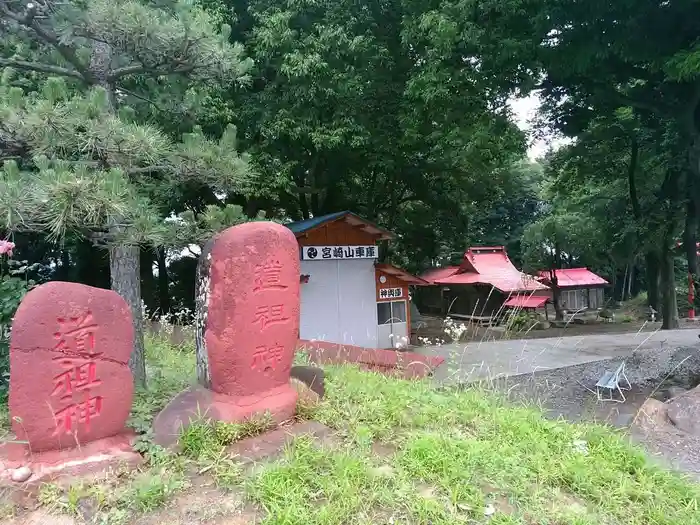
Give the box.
[0,432,143,495]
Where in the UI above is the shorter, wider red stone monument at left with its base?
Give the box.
[0,282,139,486]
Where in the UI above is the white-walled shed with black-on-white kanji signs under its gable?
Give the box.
[287,211,428,348]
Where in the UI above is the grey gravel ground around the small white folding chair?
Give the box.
[470,345,700,479]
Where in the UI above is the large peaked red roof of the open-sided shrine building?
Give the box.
[421,246,548,293]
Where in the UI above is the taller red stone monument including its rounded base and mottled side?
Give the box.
[154,222,300,445]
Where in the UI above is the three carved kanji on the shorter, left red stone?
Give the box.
[51,312,102,435]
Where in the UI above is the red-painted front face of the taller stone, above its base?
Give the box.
[205,222,300,396]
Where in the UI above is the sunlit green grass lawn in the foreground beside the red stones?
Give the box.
[0,334,700,525]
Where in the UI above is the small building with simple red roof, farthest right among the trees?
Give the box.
[539,268,609,311]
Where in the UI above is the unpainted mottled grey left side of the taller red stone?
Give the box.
[194,239,214,388]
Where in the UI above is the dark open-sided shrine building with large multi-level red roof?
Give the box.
[419,246,551,322]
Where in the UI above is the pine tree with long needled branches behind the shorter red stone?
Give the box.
[0,0,251,384]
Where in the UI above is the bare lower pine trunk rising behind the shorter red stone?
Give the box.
[109,245,146,386]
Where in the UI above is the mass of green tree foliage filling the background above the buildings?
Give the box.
[0,0,700,340]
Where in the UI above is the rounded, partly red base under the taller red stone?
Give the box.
[153,384,298,447]
